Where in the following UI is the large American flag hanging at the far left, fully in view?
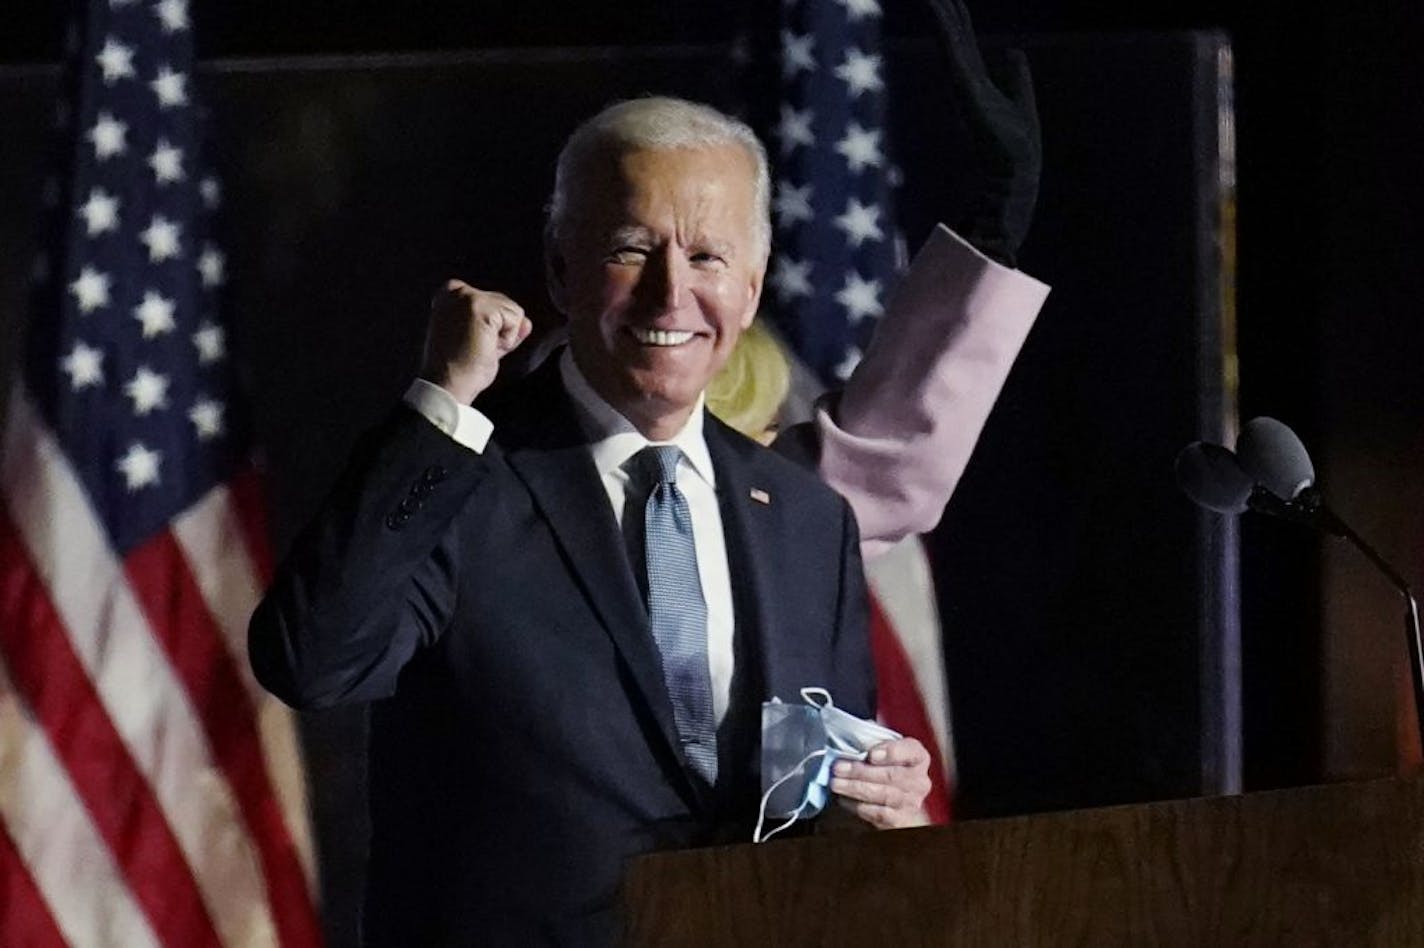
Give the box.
[0,0,320,948]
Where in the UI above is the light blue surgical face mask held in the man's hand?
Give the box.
[752,688,901,843]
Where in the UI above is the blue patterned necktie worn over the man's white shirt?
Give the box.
[631,444,716,783]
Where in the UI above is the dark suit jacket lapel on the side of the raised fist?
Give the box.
[497,361,692,784]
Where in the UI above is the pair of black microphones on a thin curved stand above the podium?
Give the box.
[1176,416,1424,743]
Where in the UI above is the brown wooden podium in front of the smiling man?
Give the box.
[625,779,1424,948]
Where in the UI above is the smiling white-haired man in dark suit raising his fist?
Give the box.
[251,98,928,945]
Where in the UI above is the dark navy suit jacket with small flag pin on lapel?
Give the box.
[251,359,874,945]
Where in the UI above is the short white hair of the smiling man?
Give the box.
[547,95,772,255]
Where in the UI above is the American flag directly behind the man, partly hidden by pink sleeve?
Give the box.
[768,0,953,821]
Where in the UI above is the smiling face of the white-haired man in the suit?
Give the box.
[550,145,766,438]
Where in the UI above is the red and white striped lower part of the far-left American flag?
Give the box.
[0,390,320,947]
